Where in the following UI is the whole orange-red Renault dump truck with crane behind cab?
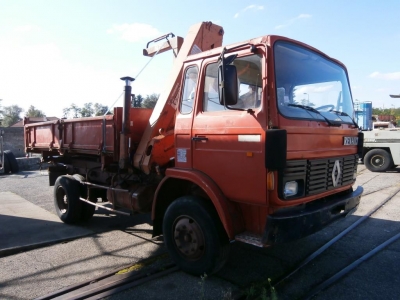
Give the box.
[25,22,363,275]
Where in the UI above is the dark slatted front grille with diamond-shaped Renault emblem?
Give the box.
[282,155,358,198]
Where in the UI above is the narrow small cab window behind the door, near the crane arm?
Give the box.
[180,66,199,114]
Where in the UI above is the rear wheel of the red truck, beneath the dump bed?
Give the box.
[54,175,83,224]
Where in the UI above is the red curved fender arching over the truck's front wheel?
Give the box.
[151,168,241,239]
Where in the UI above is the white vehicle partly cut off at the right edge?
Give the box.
[362,128,400,172]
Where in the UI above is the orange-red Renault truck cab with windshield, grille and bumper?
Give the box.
[153,36,362,274]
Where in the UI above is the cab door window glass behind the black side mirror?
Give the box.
[203,55,262,111]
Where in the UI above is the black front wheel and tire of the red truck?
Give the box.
[163,196,230,276]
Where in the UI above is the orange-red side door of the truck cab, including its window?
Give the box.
[191,55,266,205]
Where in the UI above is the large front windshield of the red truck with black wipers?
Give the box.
[274,41,354,124]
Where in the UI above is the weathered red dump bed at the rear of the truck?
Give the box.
[24,107,153,160]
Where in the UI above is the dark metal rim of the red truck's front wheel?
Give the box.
[174,216,205,260]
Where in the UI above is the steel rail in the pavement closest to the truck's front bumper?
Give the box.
[273,187,400,287]
